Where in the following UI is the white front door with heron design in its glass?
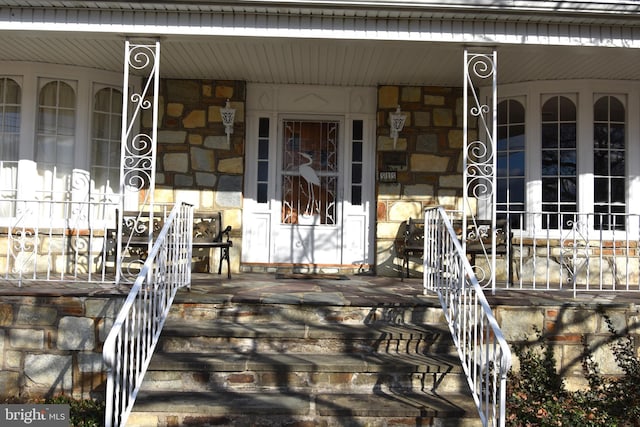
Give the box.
[273,119,342,264]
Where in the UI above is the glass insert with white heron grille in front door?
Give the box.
[281,120,339,225]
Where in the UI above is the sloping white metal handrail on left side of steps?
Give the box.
[103,203,193,427]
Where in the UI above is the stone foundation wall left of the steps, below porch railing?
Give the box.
[0,295,124,399]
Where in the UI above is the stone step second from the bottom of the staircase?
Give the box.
[143,353,468,393]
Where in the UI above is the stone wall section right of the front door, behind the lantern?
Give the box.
[376,86,477,275]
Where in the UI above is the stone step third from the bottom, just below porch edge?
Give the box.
[157,319,455,354]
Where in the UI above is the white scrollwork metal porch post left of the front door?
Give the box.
[116,40,160,283]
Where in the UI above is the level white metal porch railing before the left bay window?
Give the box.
[0,193,119,286]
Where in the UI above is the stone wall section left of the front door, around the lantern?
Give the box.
[142,79,246,271]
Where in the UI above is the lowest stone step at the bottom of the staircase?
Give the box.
[127,390,480,427]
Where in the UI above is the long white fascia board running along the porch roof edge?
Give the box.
[0,8,640,48]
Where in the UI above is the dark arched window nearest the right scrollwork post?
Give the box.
[496,99,525,228]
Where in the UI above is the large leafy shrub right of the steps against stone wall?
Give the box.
[507,317,640,427]
